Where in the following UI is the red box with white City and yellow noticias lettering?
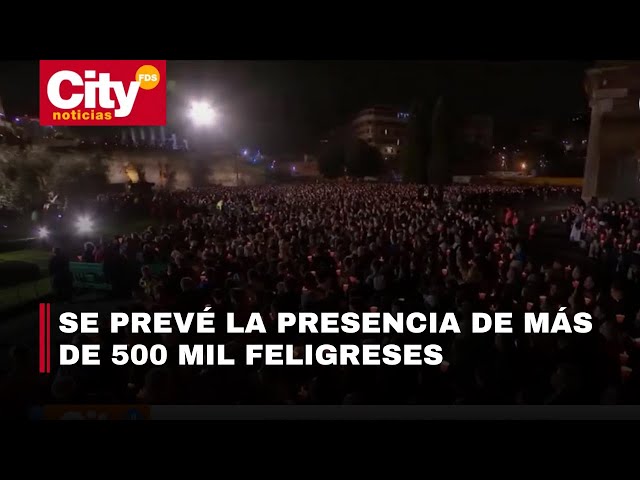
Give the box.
[40,60,167,126]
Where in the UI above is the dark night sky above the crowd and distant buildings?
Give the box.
[0,60,592,152]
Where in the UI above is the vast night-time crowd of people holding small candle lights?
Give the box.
[5,183,640,404]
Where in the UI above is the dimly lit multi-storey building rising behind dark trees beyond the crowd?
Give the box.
[351,106,409,160]
